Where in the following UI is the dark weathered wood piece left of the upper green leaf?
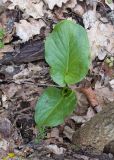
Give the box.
[0,40,44,65]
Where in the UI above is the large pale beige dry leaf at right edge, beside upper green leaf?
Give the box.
[88,21,114,58]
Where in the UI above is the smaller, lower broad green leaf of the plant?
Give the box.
[35,87,76,128]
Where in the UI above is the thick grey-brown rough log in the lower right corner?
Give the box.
[72,102,114,151]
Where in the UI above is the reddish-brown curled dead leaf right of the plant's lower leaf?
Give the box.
[80,87,99,107]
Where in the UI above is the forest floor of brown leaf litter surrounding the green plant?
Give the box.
[0,0,114,160]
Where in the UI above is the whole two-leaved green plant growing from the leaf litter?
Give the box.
[35,20,90,128]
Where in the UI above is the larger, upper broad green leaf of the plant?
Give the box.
[45,20,90,86]
